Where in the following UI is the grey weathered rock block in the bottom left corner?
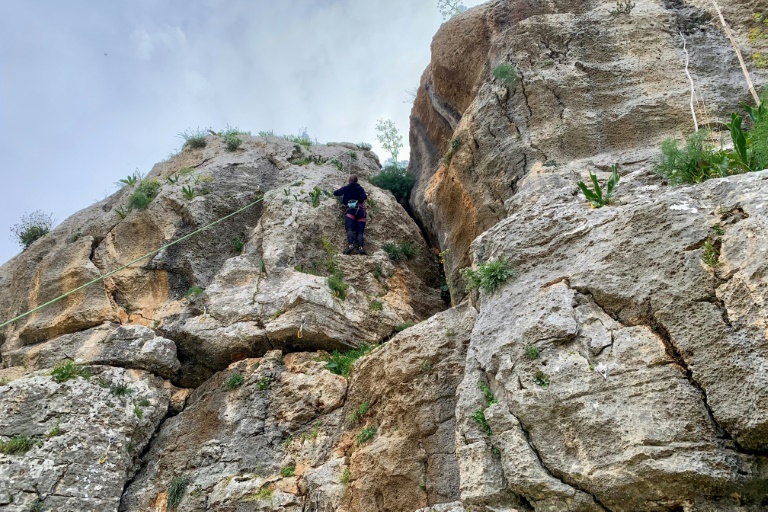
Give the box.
[0,366,171,512]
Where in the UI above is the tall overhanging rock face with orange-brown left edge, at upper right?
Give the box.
[410,0,768,302]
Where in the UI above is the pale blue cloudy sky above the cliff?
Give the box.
[0,0,483,264]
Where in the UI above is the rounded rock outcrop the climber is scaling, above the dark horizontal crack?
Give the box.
[0,136,444,386]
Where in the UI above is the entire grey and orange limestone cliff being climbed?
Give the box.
[0,0,768,512]
